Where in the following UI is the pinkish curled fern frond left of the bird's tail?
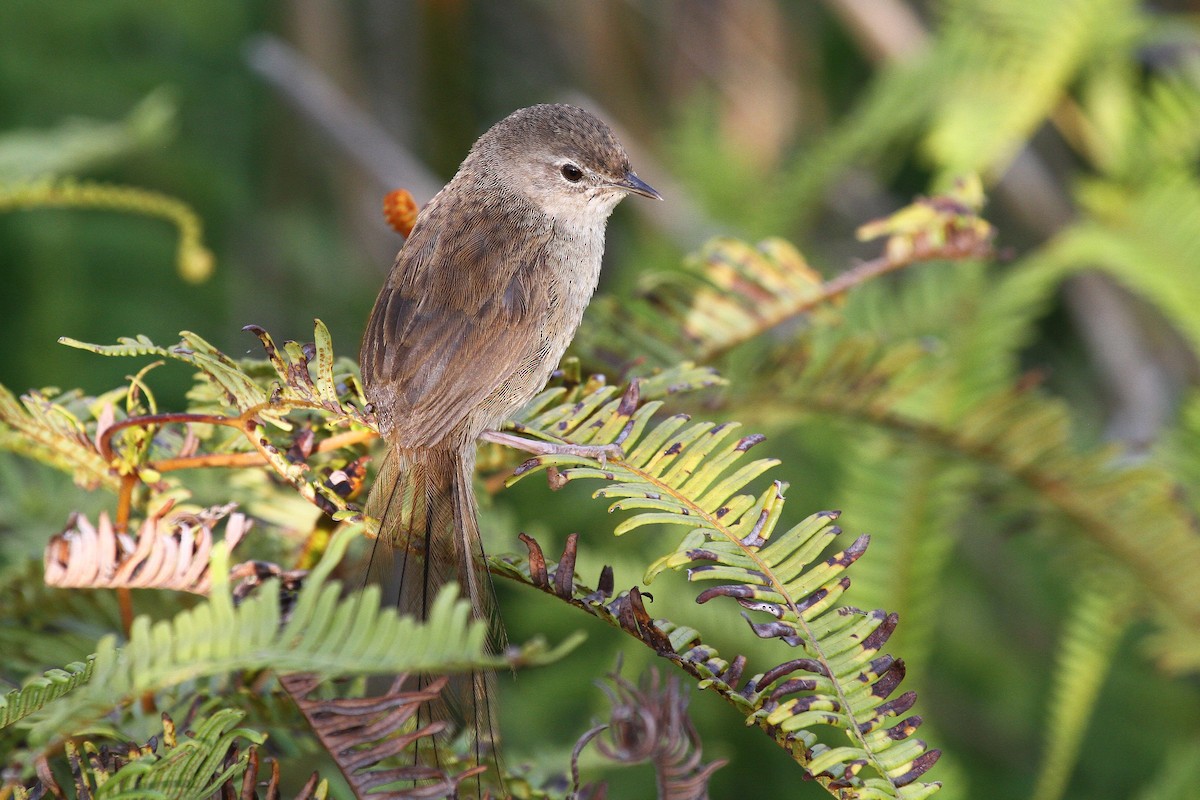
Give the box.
[44,505,251,595]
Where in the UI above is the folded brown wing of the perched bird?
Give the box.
[361,193,551,447]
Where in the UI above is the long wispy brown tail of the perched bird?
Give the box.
[367,446,505,786]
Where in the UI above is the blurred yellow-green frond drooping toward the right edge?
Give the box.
[763,337,1200,668]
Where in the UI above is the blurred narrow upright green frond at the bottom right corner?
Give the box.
[1032,570,1136,800]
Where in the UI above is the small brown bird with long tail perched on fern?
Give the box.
[360,106,662,777]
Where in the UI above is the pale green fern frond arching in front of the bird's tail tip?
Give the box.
[23,528,577,742]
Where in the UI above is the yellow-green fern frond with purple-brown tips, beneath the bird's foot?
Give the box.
[501,381,938,798]
